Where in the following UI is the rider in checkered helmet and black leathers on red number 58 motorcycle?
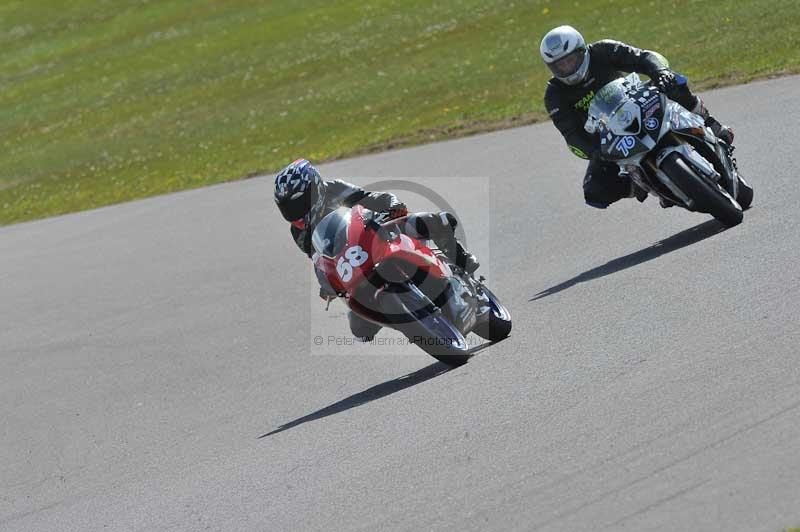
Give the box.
[274,159,479,341]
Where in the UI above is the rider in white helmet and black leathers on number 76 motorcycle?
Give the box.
[539,26,733,209]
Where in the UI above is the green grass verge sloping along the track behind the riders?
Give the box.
[0,0,800,224]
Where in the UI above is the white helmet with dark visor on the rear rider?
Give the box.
[539,26,589,85]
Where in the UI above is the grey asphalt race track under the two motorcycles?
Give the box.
[0,77,800,532]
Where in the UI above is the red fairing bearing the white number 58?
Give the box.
[315,205,452,308]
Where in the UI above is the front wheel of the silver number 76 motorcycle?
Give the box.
[661,153,744,227]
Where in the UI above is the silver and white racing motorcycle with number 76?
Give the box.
[584,73,753,227]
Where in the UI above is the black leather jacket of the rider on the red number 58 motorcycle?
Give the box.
[291,179,404,257]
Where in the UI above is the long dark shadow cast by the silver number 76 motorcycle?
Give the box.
[528,220,727,301]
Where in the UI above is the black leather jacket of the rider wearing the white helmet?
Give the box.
[544,40,668,159]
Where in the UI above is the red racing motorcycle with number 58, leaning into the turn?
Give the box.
[312,205,511,365]
